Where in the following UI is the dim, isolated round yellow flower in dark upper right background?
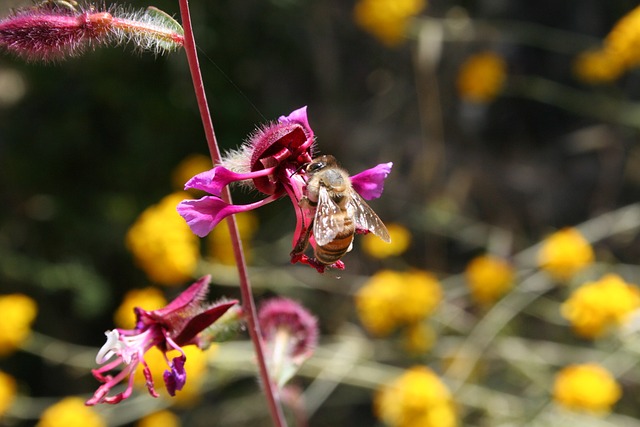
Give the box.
[456,51,507,103]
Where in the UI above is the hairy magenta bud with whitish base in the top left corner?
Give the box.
[0,1,184,61]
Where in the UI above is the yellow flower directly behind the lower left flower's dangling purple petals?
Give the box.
[134,345,217,406]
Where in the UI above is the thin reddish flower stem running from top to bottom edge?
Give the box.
[179,0,287,427]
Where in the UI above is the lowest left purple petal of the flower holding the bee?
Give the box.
[177,195,280,237]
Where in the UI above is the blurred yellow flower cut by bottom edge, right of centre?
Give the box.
[374,366,458,427]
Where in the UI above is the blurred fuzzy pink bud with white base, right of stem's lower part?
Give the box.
[258,298,318,387]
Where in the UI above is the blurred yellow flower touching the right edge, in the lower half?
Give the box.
[561,274,640,338]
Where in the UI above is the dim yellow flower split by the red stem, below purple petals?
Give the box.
[207,212,258,265]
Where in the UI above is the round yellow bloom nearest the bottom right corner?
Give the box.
[553,363,622,413]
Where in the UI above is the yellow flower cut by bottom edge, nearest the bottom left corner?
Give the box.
[36,397,107,427]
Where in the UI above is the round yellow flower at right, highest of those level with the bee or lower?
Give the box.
[538,228,594,281]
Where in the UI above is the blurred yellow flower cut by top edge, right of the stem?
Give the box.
[354,0,427,46]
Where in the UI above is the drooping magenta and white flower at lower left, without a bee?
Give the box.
[86,276,237,405]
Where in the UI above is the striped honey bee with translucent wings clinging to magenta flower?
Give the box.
[293,155,391,265]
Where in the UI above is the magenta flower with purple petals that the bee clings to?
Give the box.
[178,107,392,271]
